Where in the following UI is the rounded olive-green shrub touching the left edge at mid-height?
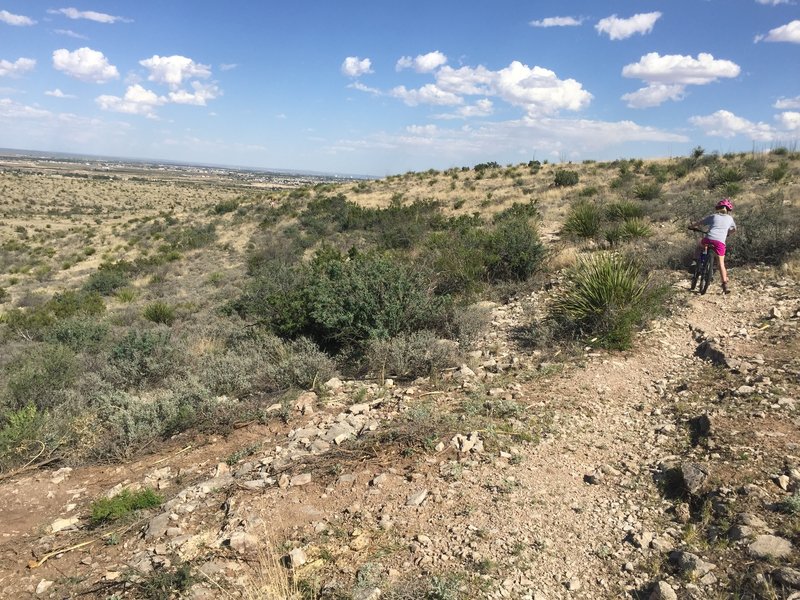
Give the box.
[5,344,79,411]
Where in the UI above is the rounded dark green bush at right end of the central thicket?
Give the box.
[483,218,546,282]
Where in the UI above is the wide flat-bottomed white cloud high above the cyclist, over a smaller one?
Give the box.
[622,52,741,85]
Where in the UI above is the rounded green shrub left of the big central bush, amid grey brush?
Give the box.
[108,329,179,387]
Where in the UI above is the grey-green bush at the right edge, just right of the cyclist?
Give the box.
[728,194,800,264]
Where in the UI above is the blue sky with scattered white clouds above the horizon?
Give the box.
[0,0,800,176]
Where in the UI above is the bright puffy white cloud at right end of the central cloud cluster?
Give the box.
[493,61,592,115]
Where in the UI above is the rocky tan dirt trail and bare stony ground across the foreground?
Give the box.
[0,271,800,600]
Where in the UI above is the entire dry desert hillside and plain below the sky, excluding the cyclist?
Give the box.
[0,145,800,600]
